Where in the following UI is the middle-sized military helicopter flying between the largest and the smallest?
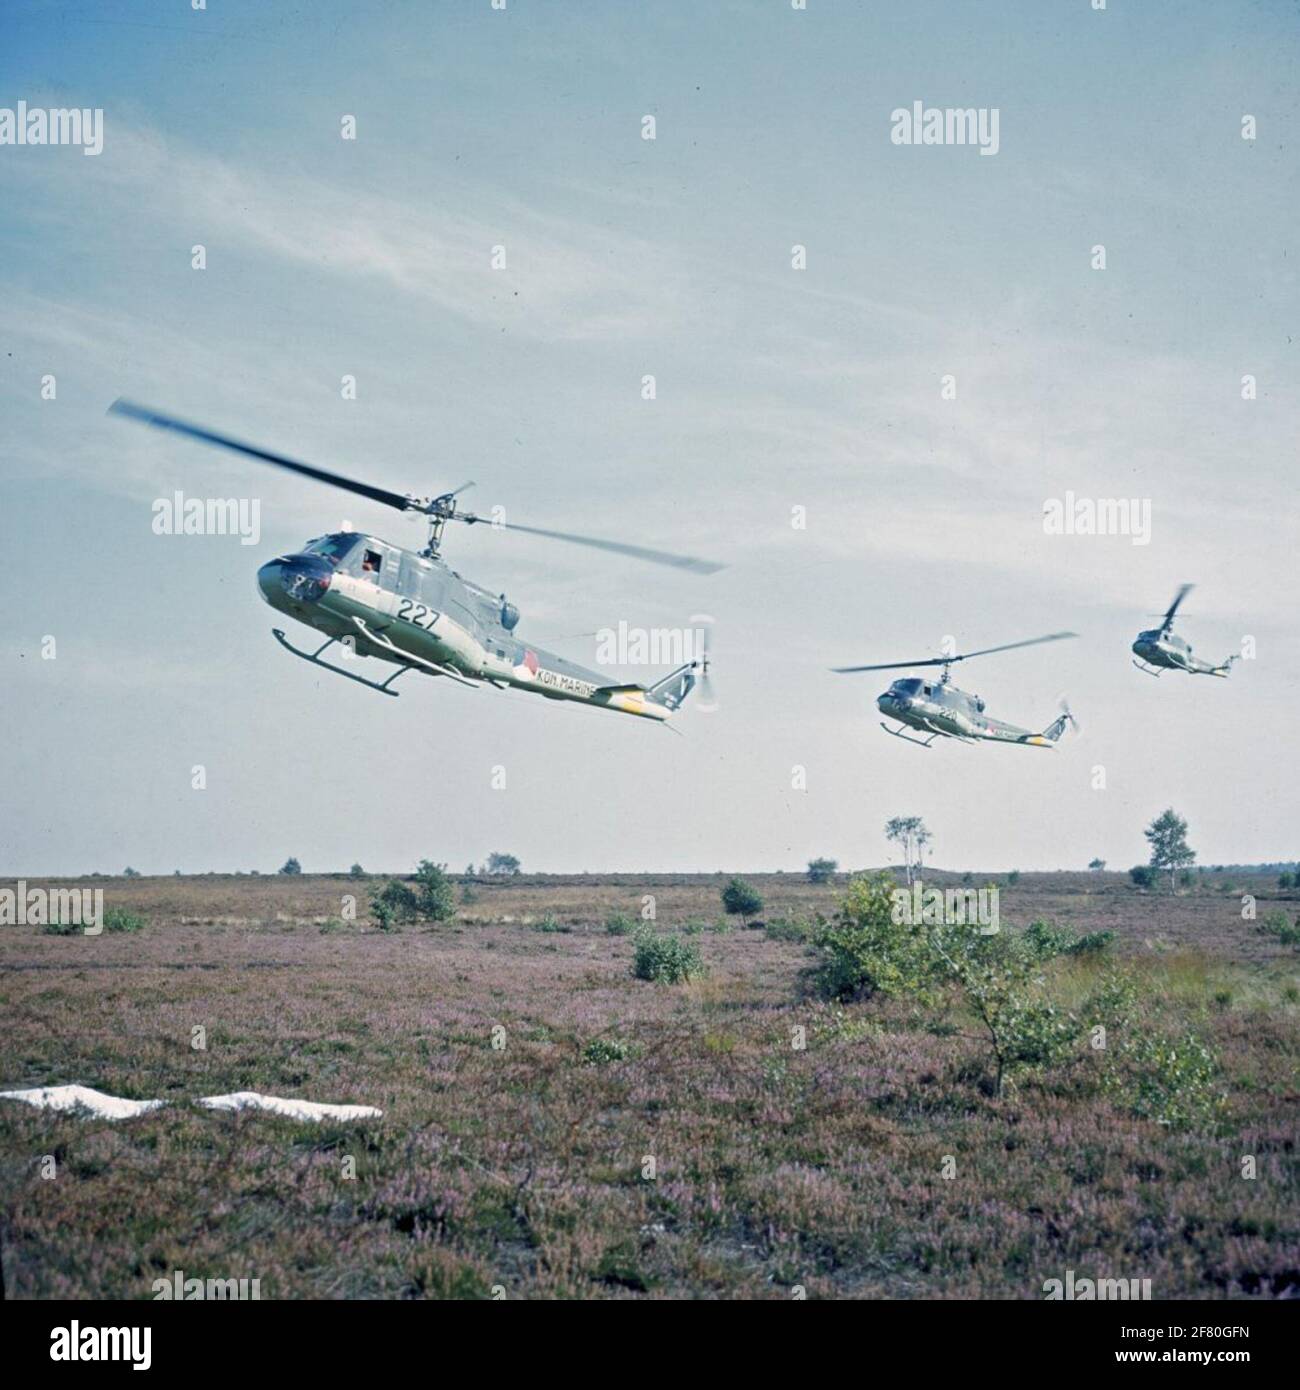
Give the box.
[833,632,1078,748]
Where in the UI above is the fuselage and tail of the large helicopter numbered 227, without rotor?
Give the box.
[257,532,698,720]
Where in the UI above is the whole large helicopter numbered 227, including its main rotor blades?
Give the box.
[108,399,723,721]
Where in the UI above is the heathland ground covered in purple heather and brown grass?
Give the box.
[0,873,1300,1298]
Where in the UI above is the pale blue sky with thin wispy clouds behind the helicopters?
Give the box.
[0,0,1300,874]
